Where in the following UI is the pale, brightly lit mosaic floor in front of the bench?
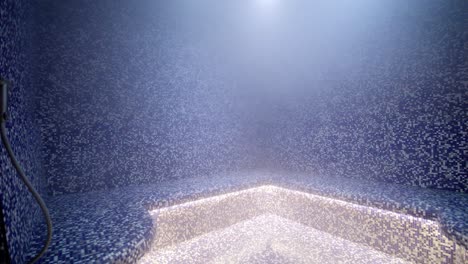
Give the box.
[139,214,410,264]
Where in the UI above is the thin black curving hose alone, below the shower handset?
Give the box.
[0,122,52,263]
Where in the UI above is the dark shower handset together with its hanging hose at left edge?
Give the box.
[0,80,52,263]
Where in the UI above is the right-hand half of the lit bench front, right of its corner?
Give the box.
[271,189,461,263]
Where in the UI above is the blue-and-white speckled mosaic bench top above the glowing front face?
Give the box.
[27,171,468,263]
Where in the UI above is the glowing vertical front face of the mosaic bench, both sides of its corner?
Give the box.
[145,185,466,263]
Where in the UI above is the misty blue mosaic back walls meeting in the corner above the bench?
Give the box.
[39,0,468,194]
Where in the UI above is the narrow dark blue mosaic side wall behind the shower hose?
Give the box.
[0,0,45,263]
